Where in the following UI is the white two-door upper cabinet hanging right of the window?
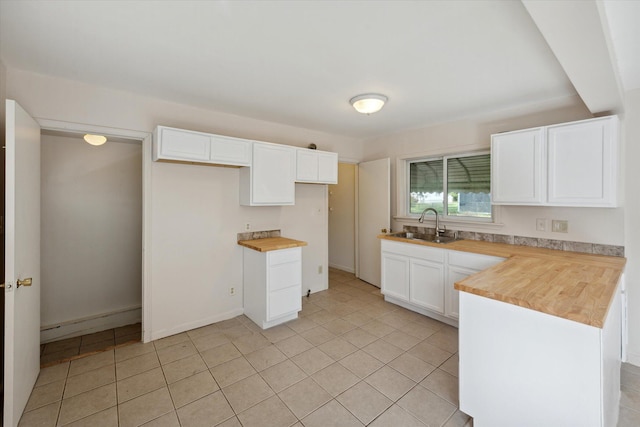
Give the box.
[491,116,618,207]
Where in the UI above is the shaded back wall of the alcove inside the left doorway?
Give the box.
[41,135,142,339]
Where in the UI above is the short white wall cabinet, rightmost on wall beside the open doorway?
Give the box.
[296,148,338,184]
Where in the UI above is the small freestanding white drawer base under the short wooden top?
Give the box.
[242,248,302,329]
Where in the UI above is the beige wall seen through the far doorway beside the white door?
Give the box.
[329,163,357,273]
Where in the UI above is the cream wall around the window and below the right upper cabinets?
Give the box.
[364,100,624,245]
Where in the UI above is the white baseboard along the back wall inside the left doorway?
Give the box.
[40,306,142,344]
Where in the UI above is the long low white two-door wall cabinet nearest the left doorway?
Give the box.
[153,126,252,166]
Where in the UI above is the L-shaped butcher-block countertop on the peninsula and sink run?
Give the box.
[378,235,626,328]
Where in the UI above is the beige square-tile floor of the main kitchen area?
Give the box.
[20,270,640,427]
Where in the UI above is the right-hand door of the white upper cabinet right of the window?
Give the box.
[547,116,617,207]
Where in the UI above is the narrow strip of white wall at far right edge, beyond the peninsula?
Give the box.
[623,89,640,366]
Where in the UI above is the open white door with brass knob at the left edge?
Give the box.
[4,100,40,427]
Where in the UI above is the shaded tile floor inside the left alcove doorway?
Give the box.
[40,323,142,368]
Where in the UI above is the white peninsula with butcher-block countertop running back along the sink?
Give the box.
[380,236,625,427]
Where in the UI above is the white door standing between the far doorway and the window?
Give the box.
[357,158,391,287]
